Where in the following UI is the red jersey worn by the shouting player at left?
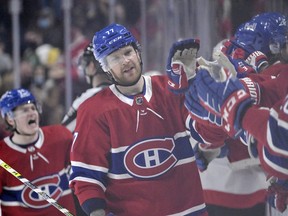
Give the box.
[0,125,75,216]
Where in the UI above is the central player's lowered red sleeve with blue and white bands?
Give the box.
[70,100,110,213]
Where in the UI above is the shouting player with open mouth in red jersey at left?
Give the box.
[0,88,75,216]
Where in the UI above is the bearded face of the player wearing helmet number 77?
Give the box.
[106,46,141,85]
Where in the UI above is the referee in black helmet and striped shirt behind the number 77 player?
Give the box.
[62,43,111,132]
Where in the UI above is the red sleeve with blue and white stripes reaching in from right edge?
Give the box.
[242,97,288,178]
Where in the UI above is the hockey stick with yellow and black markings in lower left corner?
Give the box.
[0,159,73,216]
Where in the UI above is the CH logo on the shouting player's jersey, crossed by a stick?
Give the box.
[21,175,63,209]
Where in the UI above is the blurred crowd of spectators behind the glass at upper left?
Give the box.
[0,0,140,125]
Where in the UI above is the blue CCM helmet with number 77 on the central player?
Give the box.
[93,23,138,63]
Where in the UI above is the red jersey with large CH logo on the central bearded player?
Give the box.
[70,76,207,216]
